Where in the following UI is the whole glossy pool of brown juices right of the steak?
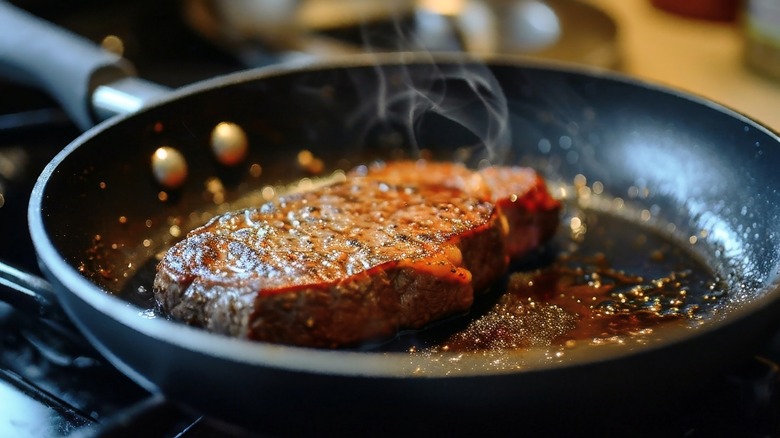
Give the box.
[405,206,725,354]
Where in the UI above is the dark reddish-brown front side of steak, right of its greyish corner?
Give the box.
[248,265,474,348]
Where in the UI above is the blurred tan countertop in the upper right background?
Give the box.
[587,0,780,132]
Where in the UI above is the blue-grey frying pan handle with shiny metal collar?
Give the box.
[0,1,169,130]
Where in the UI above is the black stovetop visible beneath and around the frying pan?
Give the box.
[0,0,780,437]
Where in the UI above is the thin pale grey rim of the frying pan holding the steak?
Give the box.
[28,54,780,378]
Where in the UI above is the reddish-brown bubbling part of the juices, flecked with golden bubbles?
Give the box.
[432,253,699,352]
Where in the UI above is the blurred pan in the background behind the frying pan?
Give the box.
[183,0,620,68]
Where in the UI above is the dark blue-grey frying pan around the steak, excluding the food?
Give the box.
[0,3,780,435]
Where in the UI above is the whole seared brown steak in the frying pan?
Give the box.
[154,161,560,348]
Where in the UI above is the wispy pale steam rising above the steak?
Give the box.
[346,6,512,164]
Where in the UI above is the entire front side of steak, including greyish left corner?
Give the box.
[154,255,474,348]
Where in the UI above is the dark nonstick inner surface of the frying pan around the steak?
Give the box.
[35,56,780,374]
